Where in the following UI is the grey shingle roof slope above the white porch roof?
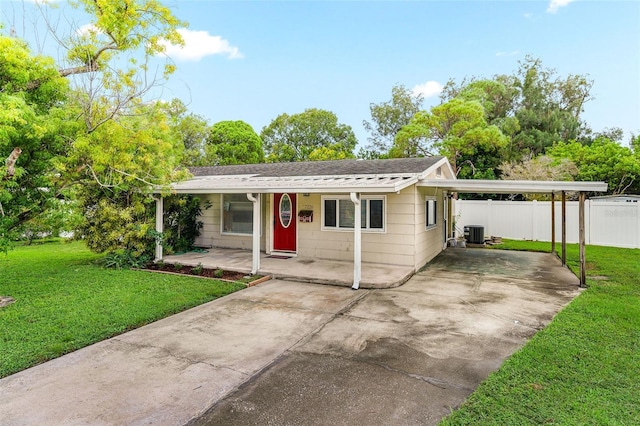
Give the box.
[189,156,443,177]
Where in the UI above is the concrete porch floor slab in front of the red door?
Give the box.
[163,248,415,288]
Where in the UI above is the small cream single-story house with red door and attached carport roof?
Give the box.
[156,156,606,289]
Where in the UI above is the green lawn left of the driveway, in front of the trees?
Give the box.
[0,242,245,377]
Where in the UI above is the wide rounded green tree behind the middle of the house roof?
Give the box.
[260,108,357,163]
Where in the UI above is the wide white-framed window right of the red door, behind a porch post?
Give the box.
[322,197,385,232]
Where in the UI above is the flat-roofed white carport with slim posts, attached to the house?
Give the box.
[417,179,607,287]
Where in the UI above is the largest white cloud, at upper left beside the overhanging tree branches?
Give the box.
[160,29,243,61]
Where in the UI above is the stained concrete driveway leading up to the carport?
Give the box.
[0,249,579,425]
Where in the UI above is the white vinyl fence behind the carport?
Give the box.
[455,200,640,248]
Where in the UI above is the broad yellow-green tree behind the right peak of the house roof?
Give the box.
[391,98,507,175]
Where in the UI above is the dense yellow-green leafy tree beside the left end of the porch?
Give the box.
[70,103,185,256]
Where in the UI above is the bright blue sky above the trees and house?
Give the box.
[0,0,640,145]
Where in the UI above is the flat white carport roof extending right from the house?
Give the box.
[418,179,607,194]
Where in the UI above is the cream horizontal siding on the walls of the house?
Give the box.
[191,186,444,270]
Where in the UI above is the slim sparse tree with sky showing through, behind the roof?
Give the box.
[360,85,423,158]
